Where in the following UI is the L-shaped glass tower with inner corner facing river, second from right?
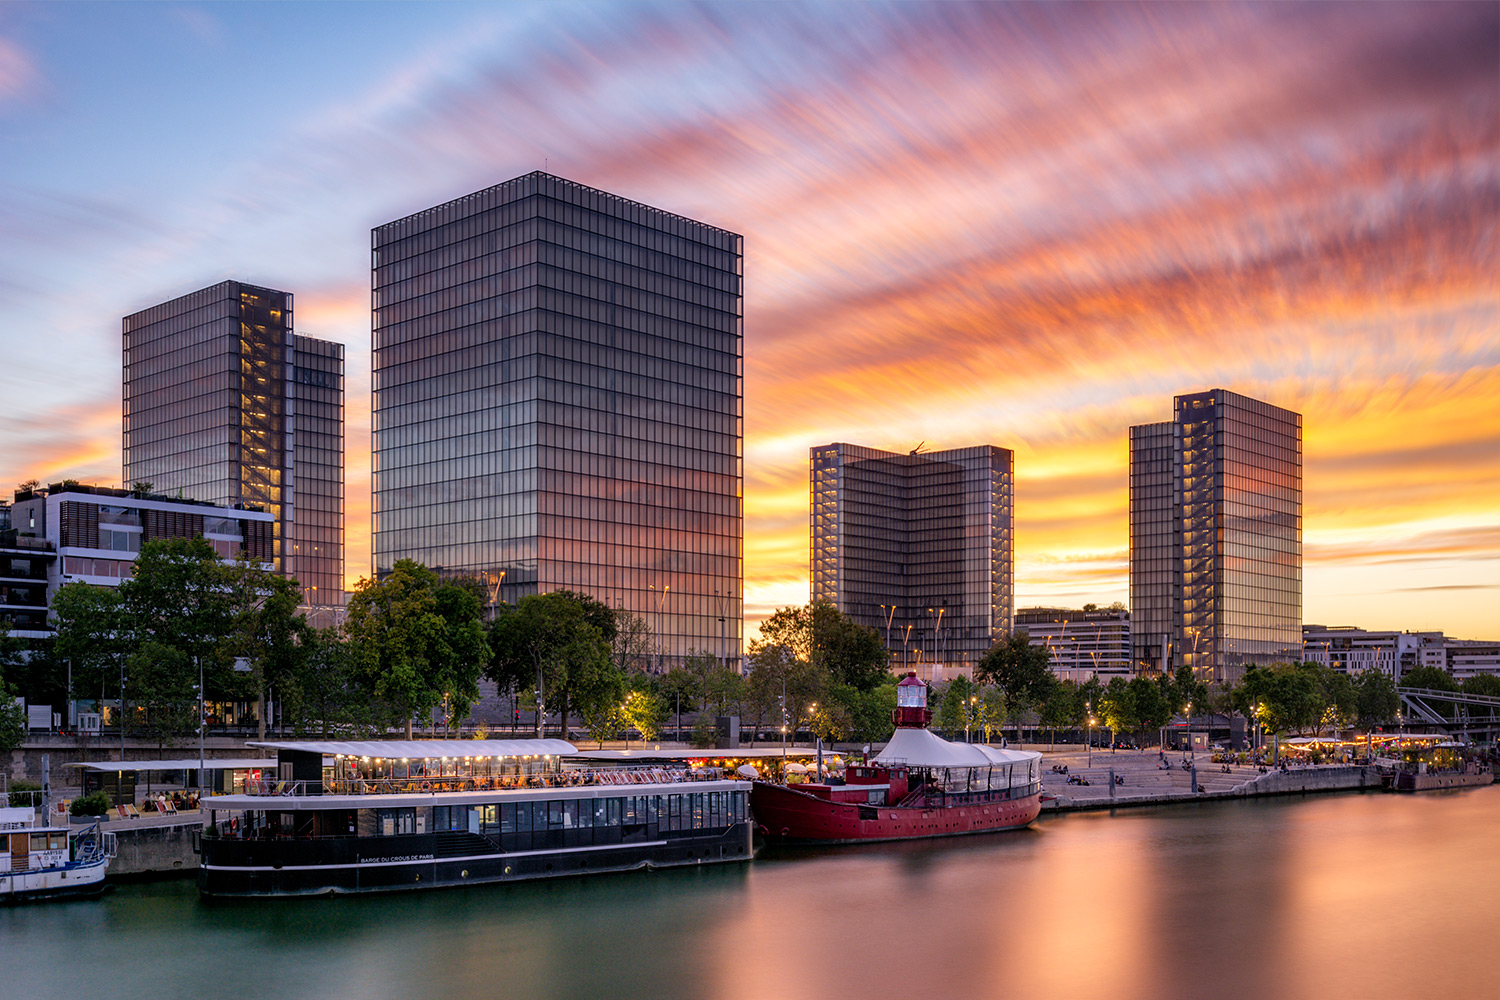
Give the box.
[810,444,1016,676]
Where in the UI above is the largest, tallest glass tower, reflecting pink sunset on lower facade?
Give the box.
[372,172,744,666]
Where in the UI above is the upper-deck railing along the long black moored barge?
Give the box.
[245,768,725,796]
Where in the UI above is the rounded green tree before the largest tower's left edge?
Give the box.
[344,559,489,739]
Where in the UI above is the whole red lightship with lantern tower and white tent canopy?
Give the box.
[750,673,1041,844]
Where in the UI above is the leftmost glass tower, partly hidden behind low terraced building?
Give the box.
[122,280,344,607]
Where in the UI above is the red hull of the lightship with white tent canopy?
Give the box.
[750,781,1041,844]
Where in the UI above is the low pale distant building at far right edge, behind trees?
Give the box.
[1302,625,1500,681]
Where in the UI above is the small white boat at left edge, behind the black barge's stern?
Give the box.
[0,807,114,903]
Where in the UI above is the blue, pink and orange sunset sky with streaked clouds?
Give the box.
[0,1,1500,639]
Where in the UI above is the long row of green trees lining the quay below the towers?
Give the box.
[0,538,1500,745]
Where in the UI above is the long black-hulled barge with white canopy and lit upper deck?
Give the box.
[198,739,753,897]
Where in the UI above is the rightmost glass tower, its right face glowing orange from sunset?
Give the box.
[1130,388,1302,684]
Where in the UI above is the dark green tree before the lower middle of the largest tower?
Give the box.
[488,591,624,733]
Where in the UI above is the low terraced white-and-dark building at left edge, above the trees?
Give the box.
[0,484,276,646]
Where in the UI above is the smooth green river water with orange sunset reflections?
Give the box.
[0,786,1500,1000]
